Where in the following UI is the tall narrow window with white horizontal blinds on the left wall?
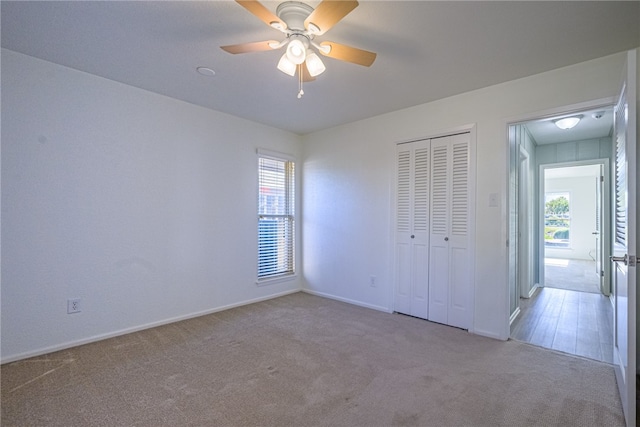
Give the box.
[258,152,295,280]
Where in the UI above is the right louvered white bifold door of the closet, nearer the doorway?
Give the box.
[428,133,471,329]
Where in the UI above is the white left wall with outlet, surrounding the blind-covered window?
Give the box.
[1,49,301,362]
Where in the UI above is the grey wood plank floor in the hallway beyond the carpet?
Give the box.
[511,288,613,363]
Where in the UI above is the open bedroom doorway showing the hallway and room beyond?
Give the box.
[509,105,613,363]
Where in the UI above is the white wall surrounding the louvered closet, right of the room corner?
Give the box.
[303,54,625,339]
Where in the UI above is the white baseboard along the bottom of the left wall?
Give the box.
[0,289,300,364]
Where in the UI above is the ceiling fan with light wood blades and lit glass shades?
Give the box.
[221,0,376,98]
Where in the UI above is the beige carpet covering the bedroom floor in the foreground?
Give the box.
[1,293,624,426]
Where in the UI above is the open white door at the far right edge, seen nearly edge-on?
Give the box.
[611,51,638,426]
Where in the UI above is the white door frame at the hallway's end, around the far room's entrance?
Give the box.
[536,158,611,296]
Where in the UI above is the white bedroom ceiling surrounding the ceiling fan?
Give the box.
[0,1,640,134]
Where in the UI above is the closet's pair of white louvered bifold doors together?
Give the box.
[394,132,472,329]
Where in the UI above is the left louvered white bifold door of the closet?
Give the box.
[394,140,429,319]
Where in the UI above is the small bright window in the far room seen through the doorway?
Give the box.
[544,193,571,248]
